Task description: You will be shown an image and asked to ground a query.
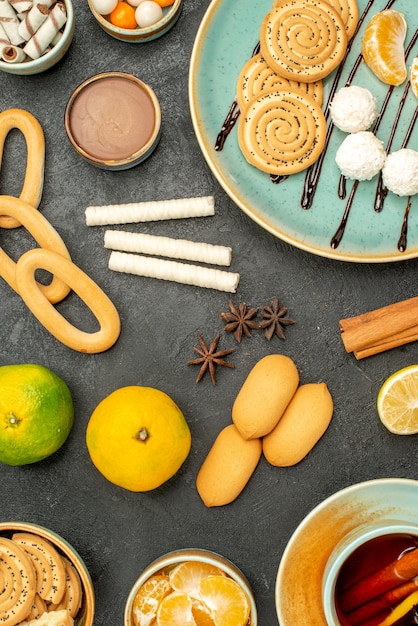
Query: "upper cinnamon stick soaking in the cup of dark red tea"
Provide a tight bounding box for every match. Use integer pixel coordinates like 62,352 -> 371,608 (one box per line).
339,548 -> 418,613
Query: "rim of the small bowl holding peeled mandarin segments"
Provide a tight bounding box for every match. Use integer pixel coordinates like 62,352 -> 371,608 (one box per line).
123,548 -> 258,626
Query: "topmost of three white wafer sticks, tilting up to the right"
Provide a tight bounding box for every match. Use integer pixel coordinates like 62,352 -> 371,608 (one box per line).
85,196 -> 215,226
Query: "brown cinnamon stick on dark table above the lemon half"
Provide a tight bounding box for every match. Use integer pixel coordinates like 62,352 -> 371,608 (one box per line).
340,297 -> 418,359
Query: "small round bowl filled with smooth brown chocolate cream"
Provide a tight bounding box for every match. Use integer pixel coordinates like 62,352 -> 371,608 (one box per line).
64,72 -> 161,170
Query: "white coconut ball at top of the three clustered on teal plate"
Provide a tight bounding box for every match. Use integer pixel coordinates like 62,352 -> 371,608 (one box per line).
329,85 -> 377,133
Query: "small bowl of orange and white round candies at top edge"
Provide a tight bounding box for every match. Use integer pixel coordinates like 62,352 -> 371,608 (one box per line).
88,0 -> 183,43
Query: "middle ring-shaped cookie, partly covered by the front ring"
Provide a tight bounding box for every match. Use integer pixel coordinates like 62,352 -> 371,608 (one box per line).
0,196 -> 70,302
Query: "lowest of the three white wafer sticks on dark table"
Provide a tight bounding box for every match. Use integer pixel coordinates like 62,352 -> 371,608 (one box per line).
109,251 -> 240,293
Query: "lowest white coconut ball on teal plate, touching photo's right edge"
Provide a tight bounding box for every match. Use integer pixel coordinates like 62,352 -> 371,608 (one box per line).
382,148 -> 418,196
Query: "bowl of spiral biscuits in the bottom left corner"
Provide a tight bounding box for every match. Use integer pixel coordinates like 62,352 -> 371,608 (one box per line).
0,522 -> 95,626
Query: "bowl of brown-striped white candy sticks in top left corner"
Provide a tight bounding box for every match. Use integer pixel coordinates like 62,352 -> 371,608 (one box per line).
0,0 -> 75,76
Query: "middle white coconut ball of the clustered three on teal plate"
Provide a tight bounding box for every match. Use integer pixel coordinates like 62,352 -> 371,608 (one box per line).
335,130 -> 386,180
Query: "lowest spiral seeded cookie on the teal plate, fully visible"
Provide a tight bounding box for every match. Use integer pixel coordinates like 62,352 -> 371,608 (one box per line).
238,90 -> 326,175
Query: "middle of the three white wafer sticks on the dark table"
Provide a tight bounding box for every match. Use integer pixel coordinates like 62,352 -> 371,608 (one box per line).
104,230 -> 232,265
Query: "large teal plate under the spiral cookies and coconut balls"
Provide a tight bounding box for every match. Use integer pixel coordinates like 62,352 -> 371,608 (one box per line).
189,0 -> 418,263
